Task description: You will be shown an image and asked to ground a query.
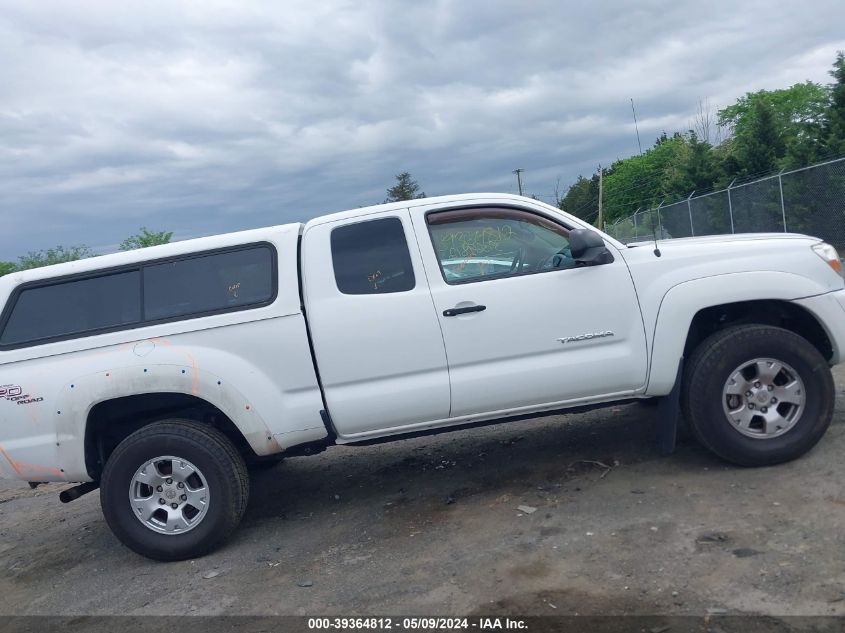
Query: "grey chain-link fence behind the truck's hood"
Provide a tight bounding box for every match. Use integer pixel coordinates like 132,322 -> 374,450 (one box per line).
605,158 -> 845,251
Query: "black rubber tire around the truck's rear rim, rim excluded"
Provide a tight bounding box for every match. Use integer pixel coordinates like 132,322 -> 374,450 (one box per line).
100,420 -> 249,561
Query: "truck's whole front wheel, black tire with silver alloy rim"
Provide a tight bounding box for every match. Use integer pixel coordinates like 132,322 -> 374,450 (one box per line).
681,325 -> 835,466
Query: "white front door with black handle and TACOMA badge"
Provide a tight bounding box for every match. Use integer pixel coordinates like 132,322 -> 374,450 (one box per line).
411,202 -> 647,418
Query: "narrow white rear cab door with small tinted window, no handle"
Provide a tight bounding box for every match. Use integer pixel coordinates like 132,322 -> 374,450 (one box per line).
301,209 -> 449,438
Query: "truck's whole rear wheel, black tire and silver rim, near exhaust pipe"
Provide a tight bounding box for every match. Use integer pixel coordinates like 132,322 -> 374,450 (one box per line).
100,420 -> 249,561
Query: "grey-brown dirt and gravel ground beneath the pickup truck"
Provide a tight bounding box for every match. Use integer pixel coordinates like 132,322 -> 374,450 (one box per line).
0,369 -> 845,616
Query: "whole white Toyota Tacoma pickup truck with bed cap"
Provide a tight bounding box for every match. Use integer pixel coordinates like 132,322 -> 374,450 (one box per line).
0,194 -> 845,560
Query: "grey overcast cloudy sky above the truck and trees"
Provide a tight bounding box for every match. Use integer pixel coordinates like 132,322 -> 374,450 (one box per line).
0,0 -> 845,260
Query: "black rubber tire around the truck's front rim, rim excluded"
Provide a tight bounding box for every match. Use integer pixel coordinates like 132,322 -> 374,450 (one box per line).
681,325 -> 835,466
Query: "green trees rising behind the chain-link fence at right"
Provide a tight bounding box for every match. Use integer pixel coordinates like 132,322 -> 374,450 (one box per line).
558,52 -> 845,222
